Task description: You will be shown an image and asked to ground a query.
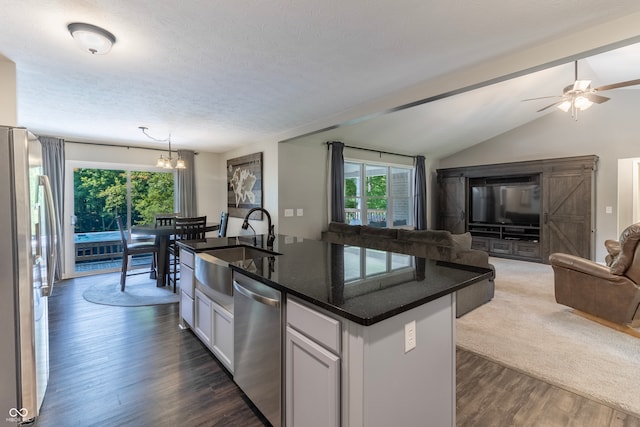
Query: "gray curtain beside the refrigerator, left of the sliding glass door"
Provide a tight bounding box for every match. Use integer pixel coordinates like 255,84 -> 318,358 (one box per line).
38,136 -> 64,281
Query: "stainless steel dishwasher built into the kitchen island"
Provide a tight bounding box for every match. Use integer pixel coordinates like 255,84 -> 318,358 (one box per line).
233,272 -> 282,427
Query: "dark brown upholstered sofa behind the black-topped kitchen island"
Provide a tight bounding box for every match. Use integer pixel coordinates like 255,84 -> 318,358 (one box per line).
322,222 -> 495,317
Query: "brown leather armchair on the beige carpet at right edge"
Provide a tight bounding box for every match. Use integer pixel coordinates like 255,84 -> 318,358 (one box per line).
549,223 -> 640,327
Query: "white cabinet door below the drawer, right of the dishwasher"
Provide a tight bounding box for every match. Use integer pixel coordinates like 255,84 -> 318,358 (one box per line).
285,327 -> 340,427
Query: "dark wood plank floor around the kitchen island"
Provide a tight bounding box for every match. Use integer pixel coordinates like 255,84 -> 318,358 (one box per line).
37,273 -> 640,427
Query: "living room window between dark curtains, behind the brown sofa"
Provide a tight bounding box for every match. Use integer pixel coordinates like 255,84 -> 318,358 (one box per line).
344,162 -> 413,227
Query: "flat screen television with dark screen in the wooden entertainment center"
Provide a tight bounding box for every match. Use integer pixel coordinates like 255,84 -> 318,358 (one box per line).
469,183 -> 540,227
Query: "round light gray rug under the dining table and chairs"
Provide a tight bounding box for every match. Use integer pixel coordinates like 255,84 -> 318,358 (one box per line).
82,273 -> 180,307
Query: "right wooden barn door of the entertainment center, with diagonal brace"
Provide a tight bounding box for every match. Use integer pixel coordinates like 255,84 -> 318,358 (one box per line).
542,167 -> 594,262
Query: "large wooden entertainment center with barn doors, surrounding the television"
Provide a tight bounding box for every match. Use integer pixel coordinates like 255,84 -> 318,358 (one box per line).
436,155 -> 598,263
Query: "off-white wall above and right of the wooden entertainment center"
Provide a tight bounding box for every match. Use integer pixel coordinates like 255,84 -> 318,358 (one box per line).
438,89 -> 640,261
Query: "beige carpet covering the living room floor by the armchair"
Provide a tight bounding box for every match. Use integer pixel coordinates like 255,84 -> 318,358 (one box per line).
456,258 -> 640,416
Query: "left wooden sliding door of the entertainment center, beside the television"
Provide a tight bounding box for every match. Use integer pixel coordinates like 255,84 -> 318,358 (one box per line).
438,176 -> 466,234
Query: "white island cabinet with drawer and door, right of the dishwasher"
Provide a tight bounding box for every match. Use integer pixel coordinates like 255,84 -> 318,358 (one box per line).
285,299 -> 341,427
